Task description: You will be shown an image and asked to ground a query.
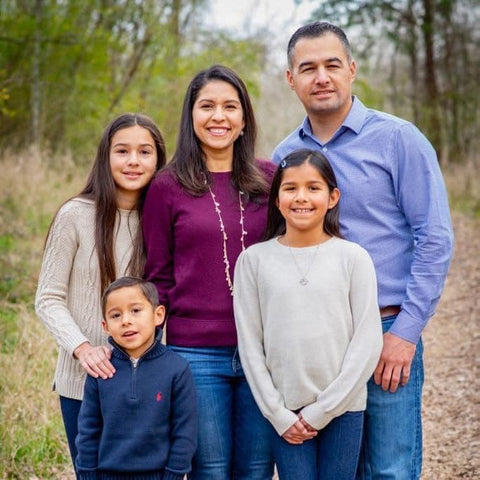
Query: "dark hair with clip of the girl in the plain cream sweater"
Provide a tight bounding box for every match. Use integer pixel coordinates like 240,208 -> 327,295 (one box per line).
263,148 -> 343,240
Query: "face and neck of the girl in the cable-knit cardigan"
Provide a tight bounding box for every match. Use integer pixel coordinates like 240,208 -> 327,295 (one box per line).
110,125 -> 157,210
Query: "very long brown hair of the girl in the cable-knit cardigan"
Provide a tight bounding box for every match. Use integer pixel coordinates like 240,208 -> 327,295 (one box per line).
47,113 -> 166,293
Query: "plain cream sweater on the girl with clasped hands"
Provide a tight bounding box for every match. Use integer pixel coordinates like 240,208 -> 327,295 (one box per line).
234,237 -> 382,435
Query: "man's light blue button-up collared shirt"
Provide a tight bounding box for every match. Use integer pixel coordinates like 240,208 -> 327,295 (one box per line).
273,97 -> 453,343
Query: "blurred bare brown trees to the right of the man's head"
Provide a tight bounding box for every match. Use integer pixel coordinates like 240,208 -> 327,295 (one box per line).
312,0 -> 480,164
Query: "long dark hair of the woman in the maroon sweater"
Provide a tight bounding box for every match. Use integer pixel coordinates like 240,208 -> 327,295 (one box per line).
167,65 -> 268,198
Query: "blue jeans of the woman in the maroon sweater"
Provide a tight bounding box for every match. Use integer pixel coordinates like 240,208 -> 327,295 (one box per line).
169,345 -> 273,480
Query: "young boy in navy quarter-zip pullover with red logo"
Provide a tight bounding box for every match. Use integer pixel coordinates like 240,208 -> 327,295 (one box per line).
76,277 -> 197,480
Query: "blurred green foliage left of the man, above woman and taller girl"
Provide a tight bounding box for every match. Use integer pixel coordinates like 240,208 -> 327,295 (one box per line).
0,0 -> 263,163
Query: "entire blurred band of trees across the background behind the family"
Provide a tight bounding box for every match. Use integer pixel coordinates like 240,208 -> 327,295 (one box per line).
0,0 -> 480,164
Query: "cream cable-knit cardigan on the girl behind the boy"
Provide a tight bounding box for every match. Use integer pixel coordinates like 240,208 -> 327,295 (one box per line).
35,198 -> 138,400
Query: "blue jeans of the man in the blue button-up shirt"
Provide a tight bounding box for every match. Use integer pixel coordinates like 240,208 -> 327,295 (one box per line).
357,317 -> 424,480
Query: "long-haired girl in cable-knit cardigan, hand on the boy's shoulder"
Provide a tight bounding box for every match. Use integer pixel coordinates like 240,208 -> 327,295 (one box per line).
35,113 -> 166,461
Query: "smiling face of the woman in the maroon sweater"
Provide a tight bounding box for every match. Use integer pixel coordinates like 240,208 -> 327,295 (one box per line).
192,80 -> 245,158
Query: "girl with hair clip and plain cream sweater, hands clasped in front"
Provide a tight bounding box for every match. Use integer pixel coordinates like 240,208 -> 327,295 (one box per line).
234,150 -> 382,480
